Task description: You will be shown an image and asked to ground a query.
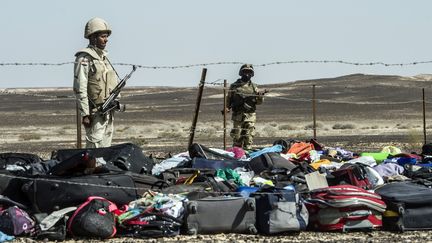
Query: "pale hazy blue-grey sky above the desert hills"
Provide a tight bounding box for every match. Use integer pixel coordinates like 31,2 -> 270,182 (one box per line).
0,0 -> 432,88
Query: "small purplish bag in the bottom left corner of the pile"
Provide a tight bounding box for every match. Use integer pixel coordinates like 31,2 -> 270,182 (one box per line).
0,206 -> 35,235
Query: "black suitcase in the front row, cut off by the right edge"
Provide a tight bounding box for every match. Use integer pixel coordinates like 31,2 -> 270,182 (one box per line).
375,182 -> 432,232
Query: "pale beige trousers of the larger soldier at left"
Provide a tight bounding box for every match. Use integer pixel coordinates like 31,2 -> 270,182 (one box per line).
86,114 -> 114,148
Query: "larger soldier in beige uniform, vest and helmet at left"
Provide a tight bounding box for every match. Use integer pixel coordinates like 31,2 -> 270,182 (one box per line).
74,18 -> 118,148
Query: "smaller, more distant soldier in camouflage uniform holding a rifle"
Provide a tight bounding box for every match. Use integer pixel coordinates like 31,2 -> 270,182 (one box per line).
227,64 -> 264,150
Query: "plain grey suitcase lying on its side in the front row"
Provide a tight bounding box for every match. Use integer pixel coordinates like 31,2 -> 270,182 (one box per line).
185,196 -> 257,235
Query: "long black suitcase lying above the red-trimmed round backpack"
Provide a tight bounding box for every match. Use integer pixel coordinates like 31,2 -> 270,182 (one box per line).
23,173 -> 164,213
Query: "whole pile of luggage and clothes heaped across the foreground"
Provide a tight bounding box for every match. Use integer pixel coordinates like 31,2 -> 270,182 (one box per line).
0,139 -> 432,241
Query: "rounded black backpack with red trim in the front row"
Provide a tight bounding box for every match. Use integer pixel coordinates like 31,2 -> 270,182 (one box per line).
68,197 -> 117,239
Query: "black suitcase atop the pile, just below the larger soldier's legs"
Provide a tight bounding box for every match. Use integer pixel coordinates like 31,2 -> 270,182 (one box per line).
51,143 -> 154,174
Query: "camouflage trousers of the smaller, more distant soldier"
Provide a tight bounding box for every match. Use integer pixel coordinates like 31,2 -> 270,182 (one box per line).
230,113 -> 256,150
